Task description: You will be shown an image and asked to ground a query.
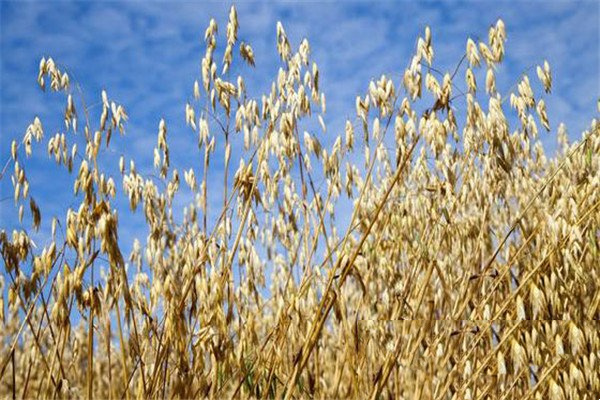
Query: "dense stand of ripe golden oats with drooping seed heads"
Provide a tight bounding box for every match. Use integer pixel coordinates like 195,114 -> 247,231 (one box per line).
0,8 -> 600,400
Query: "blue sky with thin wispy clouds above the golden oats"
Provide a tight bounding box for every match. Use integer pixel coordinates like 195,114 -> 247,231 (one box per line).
0,1 -> 600,260
